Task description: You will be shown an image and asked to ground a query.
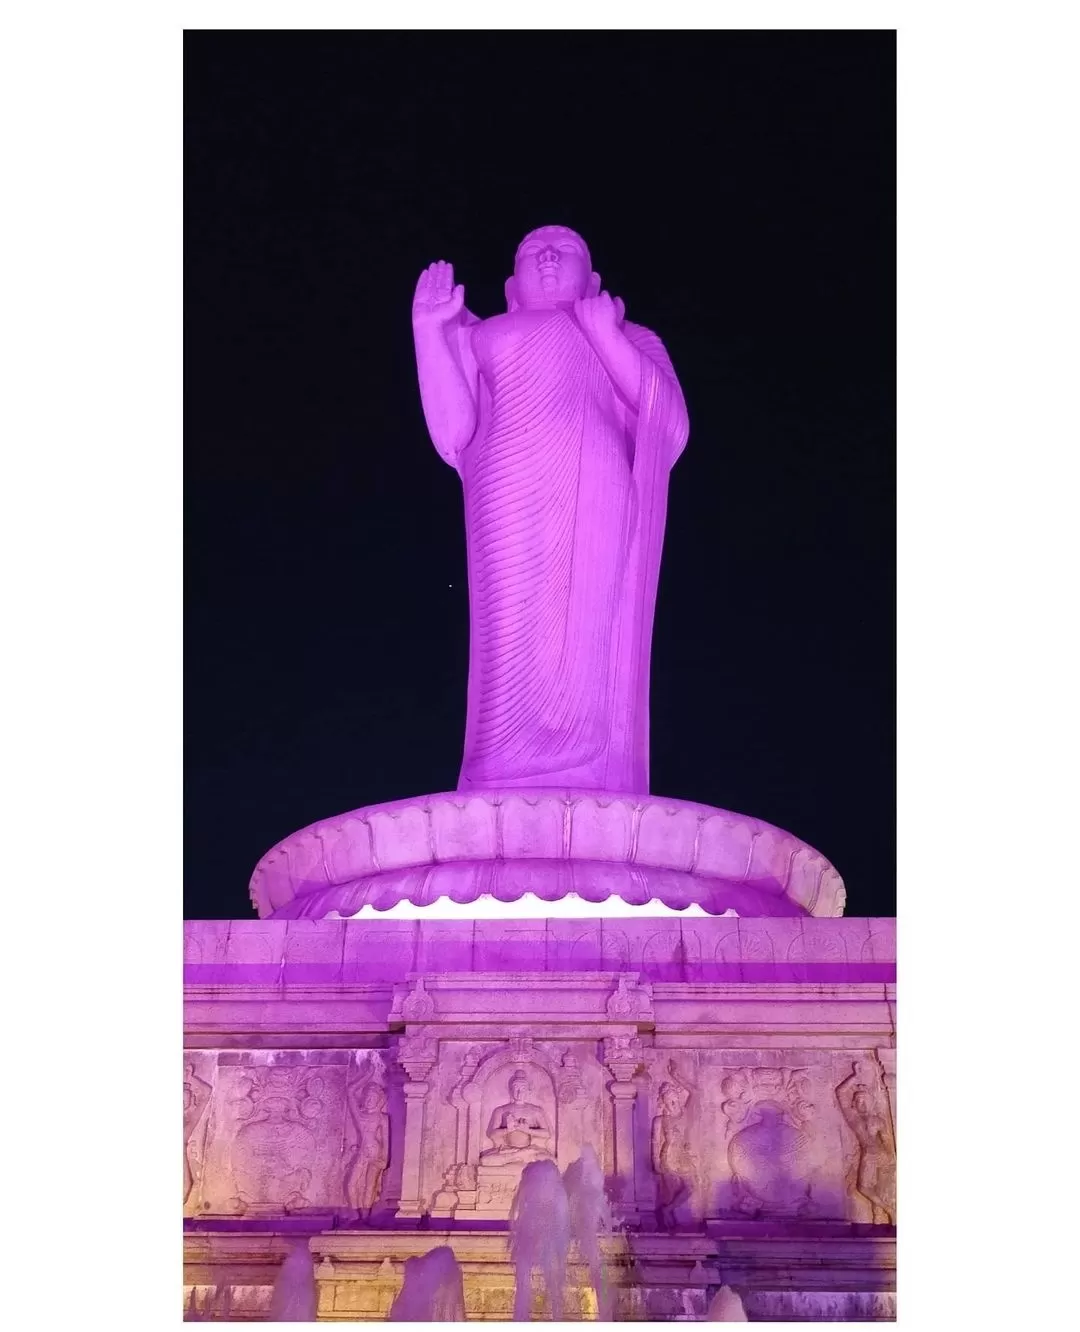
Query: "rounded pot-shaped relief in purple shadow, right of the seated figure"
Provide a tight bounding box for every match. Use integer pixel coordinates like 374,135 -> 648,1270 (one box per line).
720,1068 -> 816,1216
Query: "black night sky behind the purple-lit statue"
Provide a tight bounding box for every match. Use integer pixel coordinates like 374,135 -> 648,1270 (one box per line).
185,31 -> 896,918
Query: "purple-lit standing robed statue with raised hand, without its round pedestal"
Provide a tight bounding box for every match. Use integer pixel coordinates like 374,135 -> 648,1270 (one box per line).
413,226 -> 687,793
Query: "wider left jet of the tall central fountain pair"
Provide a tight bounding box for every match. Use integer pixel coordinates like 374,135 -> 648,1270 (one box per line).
510,1160 -> 570,1323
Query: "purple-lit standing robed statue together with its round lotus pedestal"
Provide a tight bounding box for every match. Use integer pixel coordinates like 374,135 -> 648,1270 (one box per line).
245,226 -> 844,921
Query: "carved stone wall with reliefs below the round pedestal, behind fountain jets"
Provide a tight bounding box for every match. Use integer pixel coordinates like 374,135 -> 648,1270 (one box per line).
184,918 -> 896,1319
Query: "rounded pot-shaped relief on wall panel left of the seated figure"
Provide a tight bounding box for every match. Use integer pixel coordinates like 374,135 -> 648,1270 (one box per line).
230,1067 -> 324,1212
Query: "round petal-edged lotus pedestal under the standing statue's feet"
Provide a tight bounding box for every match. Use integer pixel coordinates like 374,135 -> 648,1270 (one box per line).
250,787 -> 846,920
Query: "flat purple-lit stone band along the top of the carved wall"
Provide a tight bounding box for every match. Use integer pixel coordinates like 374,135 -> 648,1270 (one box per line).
184,916 -> 896,991
